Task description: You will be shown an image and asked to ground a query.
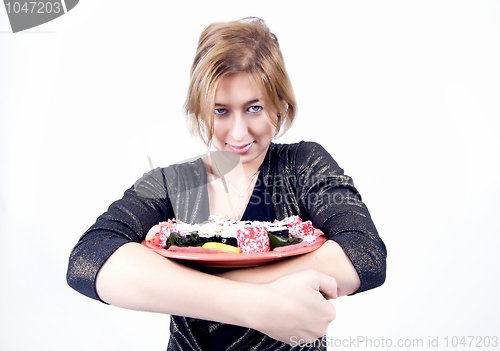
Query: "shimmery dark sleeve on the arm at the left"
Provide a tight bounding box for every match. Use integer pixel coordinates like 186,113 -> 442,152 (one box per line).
66,168 -> 172,300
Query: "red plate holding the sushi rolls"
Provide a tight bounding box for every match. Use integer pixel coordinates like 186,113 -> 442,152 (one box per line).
142,236 -> 326,268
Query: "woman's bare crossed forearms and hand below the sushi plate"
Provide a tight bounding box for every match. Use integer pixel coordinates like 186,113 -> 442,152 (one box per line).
96,240 -> 359,342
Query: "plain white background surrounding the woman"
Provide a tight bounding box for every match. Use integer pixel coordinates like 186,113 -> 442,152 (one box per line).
0,0 -> 500,351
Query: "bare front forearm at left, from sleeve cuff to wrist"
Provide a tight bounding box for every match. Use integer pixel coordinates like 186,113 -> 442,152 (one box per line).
96,243 -> 257,325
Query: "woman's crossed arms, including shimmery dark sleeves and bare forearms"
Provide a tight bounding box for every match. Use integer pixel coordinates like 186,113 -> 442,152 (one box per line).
74,144 -> 386,342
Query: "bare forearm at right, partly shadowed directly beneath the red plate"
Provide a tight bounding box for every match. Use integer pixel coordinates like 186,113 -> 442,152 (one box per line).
220,240 -> 360,296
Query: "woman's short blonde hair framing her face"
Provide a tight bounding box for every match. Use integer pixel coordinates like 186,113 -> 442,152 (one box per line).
185,17 -> 297,145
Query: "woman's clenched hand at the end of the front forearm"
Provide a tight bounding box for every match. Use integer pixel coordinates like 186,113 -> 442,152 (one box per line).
252,270 -> 338,344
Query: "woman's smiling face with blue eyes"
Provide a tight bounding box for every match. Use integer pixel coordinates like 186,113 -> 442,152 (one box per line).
212,73 -> 276,166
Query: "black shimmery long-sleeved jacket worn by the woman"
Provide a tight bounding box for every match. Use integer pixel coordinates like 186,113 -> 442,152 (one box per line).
67,142 -> 387,350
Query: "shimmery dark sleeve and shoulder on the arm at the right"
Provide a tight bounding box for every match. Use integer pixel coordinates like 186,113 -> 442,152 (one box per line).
263,142 -> 387,292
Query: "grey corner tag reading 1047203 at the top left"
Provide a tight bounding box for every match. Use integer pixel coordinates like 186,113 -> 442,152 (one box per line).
4,0 -> 79,33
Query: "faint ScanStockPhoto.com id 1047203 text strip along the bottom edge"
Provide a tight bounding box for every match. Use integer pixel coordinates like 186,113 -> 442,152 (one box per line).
290,335 -> 500,349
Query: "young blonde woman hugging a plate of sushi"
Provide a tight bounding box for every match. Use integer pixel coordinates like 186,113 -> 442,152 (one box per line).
68,18 -> 386,350
